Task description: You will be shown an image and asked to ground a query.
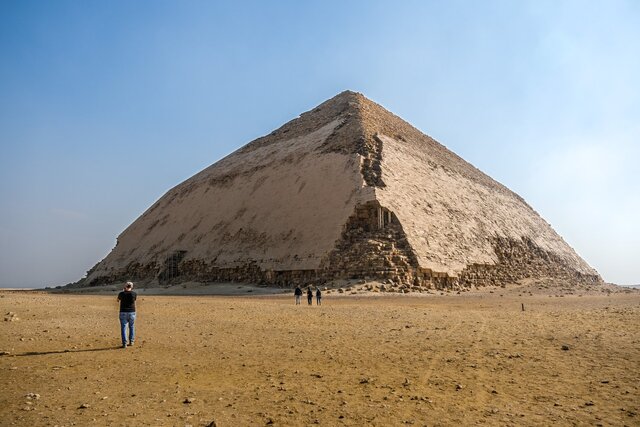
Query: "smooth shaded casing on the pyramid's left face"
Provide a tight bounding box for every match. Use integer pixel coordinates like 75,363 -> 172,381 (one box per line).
92,120 -> 372,284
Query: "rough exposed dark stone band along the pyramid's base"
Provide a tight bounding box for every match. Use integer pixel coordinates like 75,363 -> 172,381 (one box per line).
78,234 -> 603,291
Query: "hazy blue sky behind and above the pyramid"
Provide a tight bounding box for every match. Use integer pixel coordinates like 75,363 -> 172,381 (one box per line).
0,0 -> 640,287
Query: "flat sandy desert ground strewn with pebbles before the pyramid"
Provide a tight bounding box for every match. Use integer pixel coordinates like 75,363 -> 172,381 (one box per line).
0,289 -> 640,426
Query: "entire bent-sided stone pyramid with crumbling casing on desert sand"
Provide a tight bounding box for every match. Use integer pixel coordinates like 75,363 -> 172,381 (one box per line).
81,91 -> 602,287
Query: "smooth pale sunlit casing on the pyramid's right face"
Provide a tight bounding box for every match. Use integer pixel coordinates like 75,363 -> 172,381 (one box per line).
376,135 -> 597,275
